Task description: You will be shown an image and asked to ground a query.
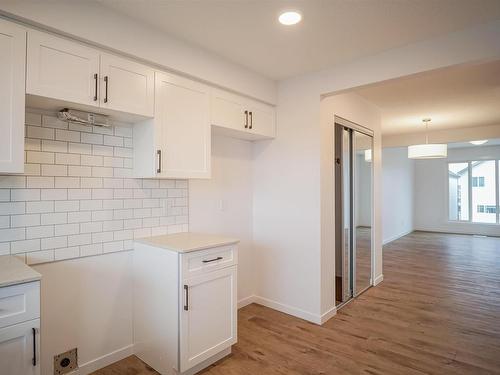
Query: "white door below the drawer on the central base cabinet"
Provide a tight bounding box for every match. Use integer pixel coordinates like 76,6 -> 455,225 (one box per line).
180,267 -> 237,372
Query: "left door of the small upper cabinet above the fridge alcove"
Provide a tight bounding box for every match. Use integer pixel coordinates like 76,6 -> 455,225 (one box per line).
211,89 -> 248,131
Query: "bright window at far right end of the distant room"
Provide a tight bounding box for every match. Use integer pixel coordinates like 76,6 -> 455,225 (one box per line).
448,160 -> 500,224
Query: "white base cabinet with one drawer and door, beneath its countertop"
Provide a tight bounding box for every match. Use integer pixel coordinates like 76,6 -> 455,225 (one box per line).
134,242 -> 237,375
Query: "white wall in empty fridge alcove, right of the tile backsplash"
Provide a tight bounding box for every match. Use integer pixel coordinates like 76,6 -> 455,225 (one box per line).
189,136 -> 255,303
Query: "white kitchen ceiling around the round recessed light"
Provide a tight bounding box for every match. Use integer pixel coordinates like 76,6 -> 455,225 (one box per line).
94,0 -> 500,79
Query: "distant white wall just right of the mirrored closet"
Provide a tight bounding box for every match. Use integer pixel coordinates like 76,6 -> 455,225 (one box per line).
382,147 -> 415,244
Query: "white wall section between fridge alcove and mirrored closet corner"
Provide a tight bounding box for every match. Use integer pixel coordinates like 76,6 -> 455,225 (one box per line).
253,78 -> 320,321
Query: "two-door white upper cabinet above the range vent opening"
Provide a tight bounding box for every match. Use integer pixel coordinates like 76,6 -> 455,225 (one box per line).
26,30 -> 154,117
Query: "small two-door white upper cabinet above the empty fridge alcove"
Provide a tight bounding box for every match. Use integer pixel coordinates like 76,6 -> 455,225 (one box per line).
211,89 -> 276,140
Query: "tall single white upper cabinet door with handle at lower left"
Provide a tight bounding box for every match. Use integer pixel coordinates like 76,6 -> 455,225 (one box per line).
155,73 -> 211,178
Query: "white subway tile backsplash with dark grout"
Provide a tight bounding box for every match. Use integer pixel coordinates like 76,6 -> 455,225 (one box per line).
0,112 -> 188,264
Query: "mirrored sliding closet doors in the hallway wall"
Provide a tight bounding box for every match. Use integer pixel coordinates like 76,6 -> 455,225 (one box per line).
334,117 -> 373,307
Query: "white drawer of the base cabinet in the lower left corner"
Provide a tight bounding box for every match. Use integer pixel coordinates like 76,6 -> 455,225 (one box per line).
0,281 -> 40,328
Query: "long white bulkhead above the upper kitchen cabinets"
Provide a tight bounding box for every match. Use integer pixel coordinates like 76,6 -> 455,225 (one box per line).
0,0 -> 276,104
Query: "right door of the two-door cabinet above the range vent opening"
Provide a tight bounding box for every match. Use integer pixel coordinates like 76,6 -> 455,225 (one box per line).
100,54 -> 154,117
